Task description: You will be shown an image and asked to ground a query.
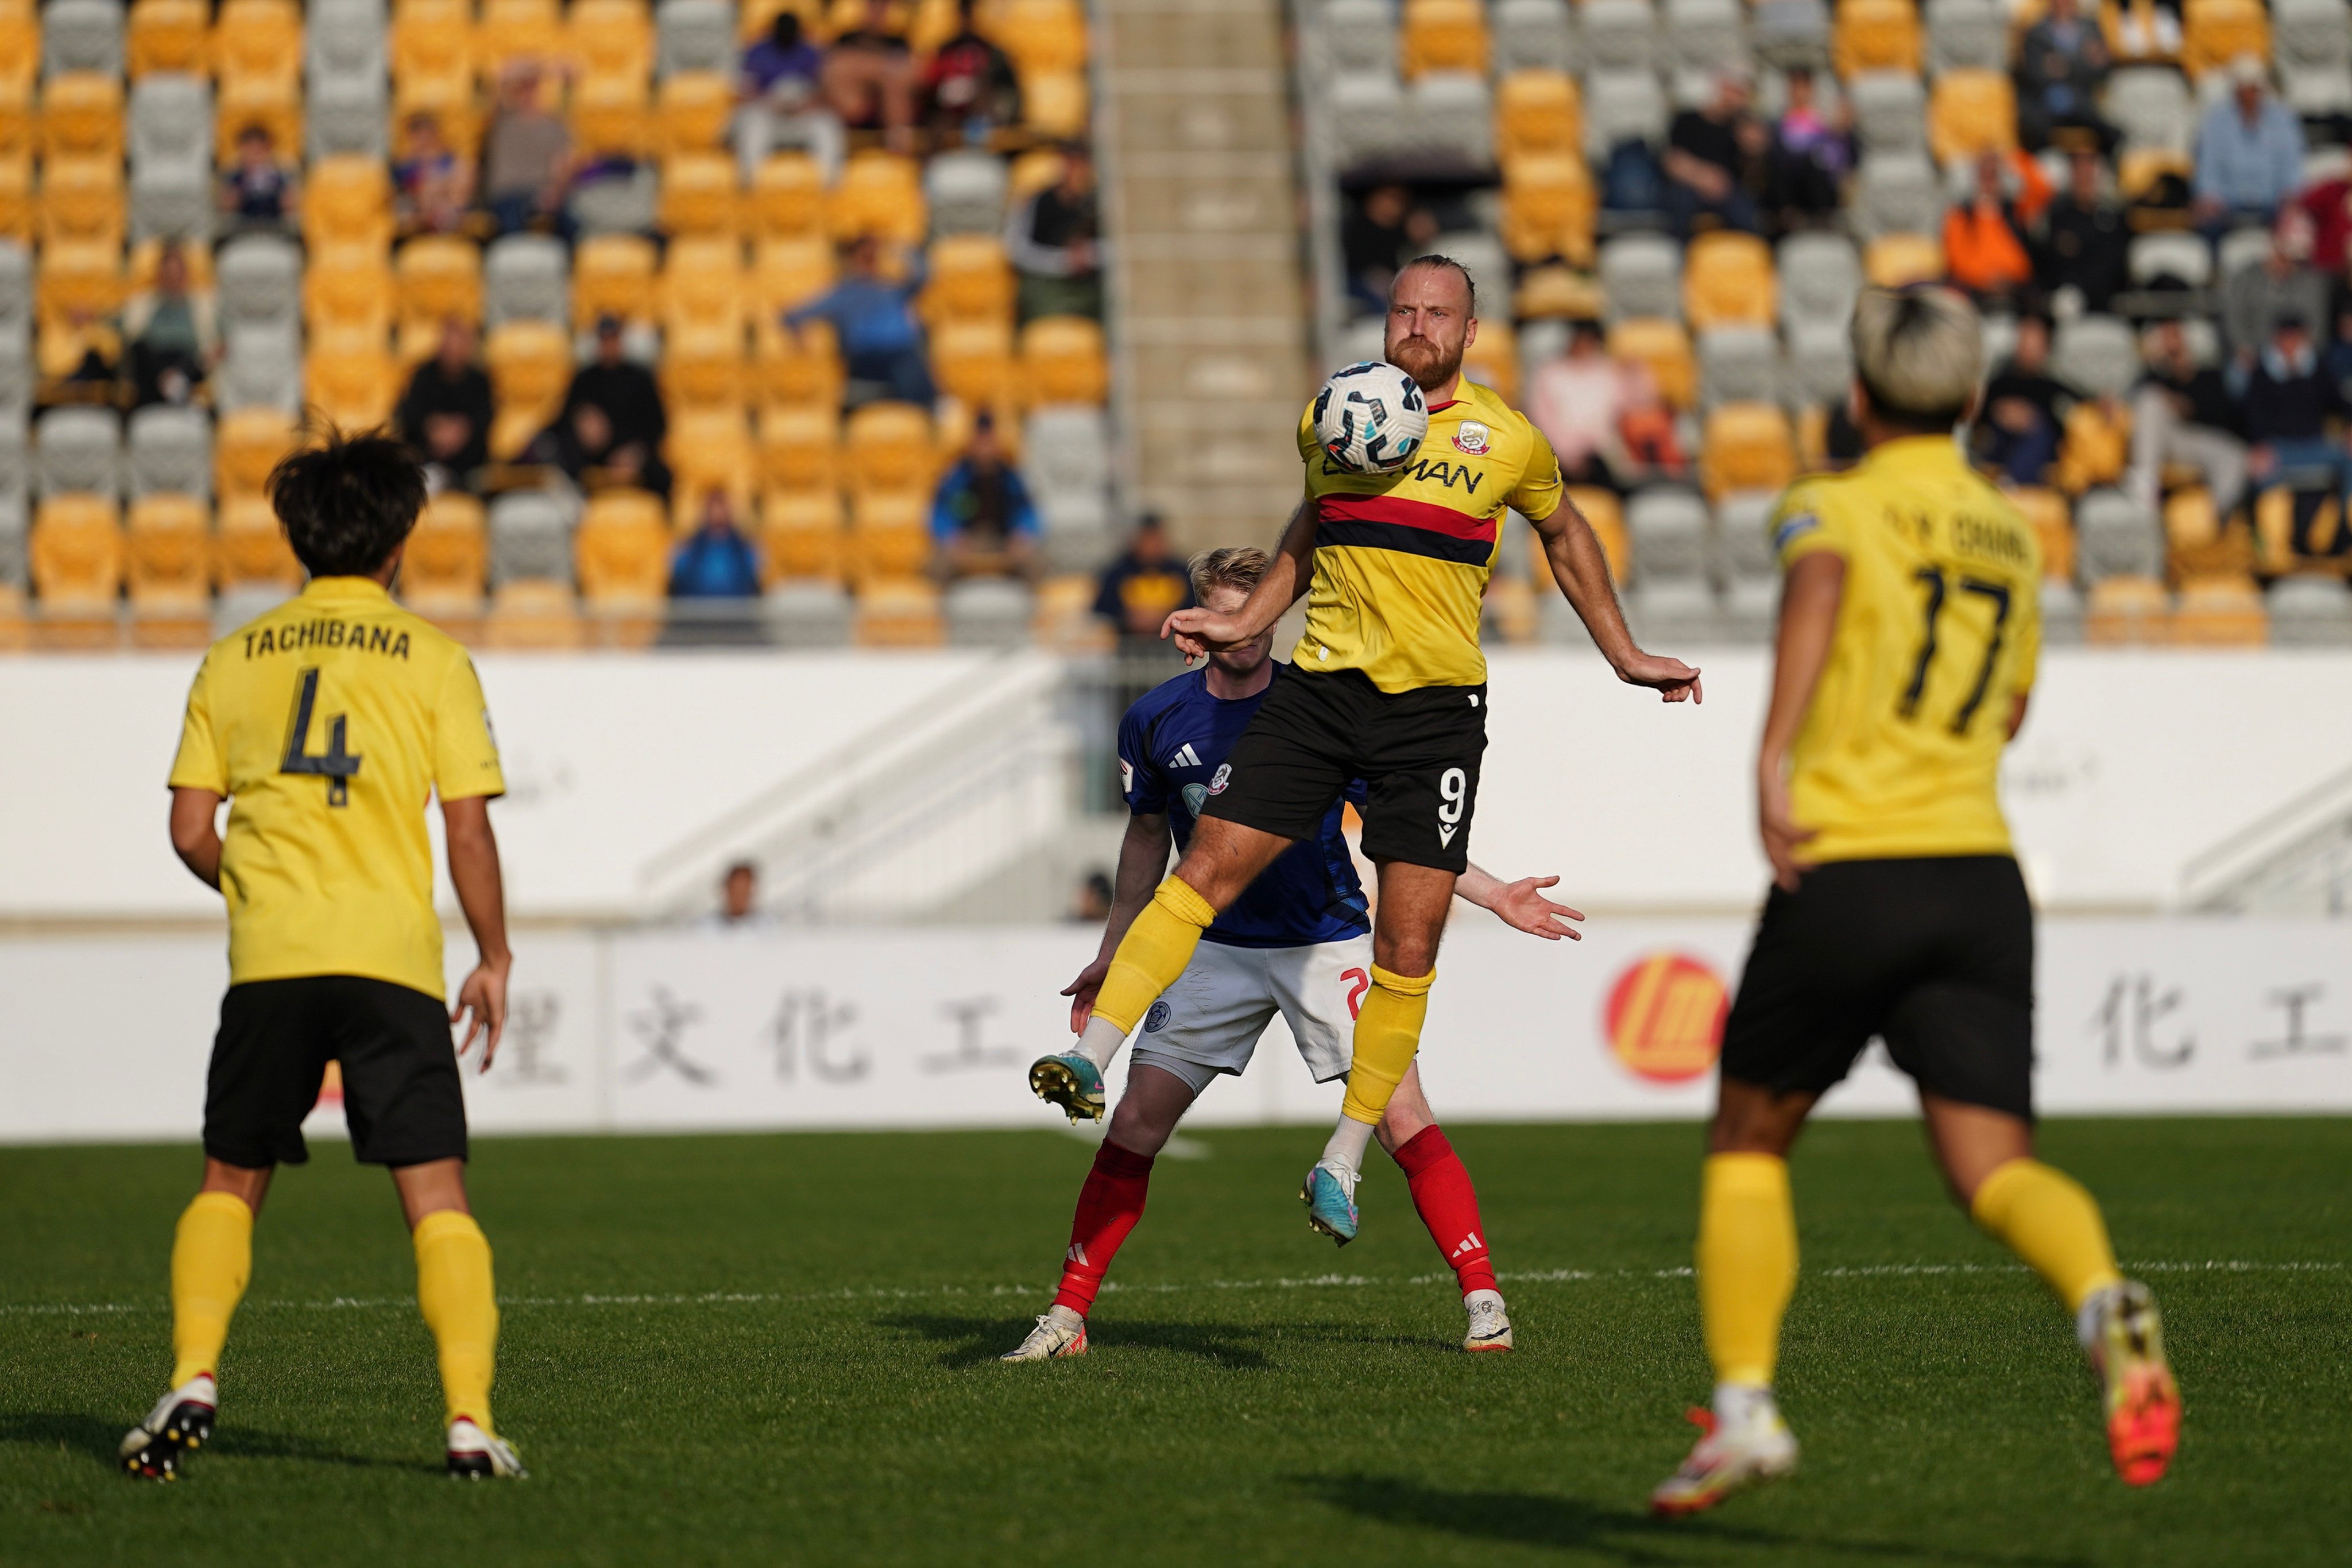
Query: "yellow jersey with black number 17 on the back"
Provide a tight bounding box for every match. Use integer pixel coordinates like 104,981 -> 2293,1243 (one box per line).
1771,435 -> 2041,861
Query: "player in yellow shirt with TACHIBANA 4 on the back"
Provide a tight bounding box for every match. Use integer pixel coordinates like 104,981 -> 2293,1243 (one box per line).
122,438 -> 522,1478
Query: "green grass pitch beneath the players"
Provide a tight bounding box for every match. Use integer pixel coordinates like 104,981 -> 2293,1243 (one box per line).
0,1119 -> 2352,1568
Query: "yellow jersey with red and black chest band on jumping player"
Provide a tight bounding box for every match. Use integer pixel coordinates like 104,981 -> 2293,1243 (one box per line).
1291,378 -> 1562,691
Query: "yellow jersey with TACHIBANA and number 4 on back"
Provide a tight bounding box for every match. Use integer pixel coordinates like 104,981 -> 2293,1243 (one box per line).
172,576 -> 506,997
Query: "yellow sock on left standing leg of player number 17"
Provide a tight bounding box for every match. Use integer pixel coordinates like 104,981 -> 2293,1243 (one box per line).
1698,1154 -> 1797,1387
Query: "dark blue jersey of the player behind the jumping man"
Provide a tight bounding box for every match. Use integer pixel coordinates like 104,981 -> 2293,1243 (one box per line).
1120,663 -> 1371,947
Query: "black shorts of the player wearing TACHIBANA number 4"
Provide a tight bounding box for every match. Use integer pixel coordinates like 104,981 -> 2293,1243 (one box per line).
204,975 -> 466,1168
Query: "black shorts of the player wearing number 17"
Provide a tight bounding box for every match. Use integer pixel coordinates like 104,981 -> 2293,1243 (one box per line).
1724,855 -> 2034,1121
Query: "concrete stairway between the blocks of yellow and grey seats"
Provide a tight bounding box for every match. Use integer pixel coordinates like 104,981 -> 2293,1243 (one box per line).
1094,0 -> 1315,550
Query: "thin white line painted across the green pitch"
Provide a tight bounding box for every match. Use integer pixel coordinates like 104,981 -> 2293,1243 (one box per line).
0,1258 -> 2345,1317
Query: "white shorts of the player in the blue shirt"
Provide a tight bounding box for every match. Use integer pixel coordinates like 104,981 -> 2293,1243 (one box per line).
1136,933 -> 1371,1093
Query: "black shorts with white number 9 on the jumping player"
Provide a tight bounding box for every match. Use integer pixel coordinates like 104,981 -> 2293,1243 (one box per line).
1202,668 -> 1487,874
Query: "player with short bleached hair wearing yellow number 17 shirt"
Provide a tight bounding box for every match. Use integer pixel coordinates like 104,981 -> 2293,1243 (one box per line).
1651,289 -> 2180,1514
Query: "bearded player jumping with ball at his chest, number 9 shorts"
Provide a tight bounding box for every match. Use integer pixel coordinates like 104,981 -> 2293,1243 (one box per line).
1030,256 -> 1700,1246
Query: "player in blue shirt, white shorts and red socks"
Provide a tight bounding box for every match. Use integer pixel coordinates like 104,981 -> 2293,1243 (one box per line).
1004,550 -> 1583,1361
